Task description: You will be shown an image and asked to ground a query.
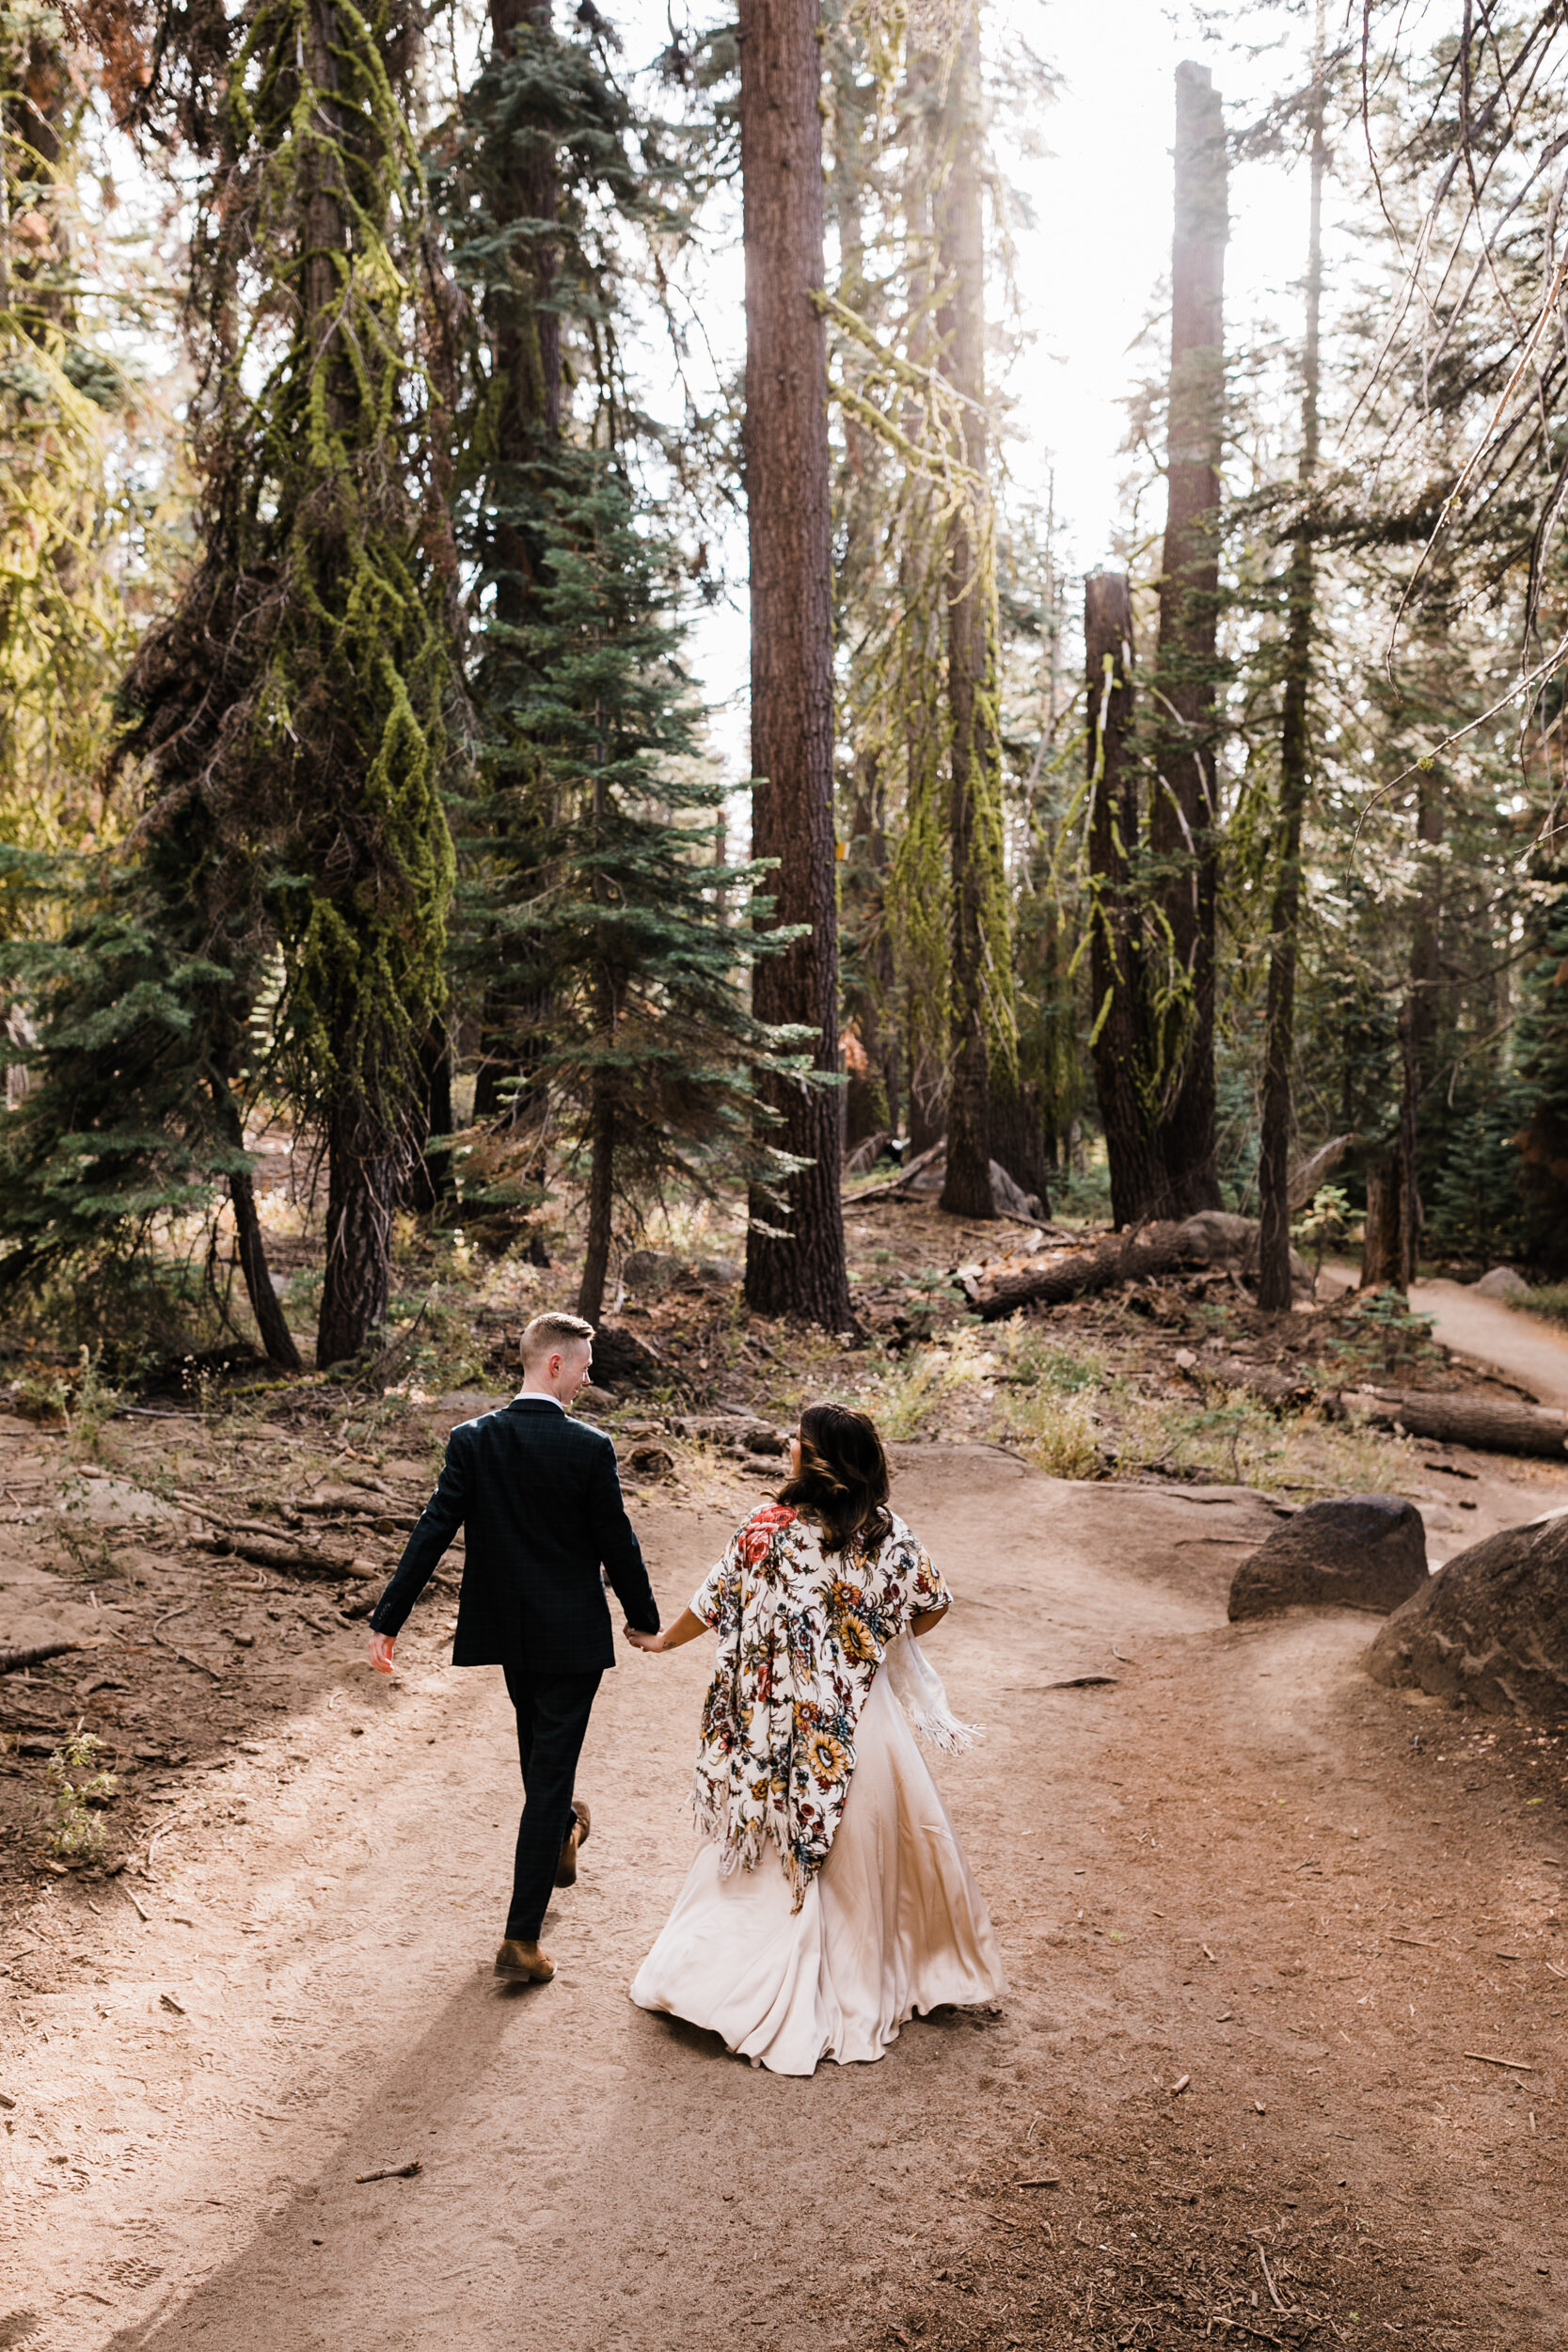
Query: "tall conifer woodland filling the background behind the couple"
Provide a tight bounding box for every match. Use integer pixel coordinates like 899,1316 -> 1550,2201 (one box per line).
0,0 -> 1568,1376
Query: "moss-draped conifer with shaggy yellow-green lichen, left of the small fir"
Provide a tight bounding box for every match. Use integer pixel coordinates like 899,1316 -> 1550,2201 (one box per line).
115,0 -> 461,1362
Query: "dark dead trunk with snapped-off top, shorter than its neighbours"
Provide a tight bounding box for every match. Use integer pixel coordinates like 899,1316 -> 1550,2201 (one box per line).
1084,572 -> 1166,1226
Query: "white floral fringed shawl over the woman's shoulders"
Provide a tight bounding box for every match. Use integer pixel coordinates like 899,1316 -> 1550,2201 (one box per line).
691,1503 -> 950,1910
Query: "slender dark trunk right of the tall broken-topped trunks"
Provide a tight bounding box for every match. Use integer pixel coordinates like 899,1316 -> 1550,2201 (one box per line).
1258,45 -> 1326,1315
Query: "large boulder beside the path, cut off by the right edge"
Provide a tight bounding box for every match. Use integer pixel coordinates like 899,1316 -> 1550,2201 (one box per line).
1366,1515 -> 1568,1722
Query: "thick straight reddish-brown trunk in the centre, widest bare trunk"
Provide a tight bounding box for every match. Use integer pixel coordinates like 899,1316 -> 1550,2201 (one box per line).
740,0 -> 853,1331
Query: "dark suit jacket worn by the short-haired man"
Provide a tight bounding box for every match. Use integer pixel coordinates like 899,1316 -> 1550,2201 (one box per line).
372,1400 -> 658,1675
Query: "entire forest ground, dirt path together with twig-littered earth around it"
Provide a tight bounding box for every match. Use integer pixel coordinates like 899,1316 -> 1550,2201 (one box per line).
0,1202 -> 1568,2352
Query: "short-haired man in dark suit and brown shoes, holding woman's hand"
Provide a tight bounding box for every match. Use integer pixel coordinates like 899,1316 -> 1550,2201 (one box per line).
369,1315 -> 658,1983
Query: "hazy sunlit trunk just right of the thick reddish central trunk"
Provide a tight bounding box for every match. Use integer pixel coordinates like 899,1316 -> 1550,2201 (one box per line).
936,8 -> 1011,1216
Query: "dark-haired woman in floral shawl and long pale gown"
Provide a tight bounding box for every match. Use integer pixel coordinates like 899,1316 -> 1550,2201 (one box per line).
627,1405 -> 1006,2074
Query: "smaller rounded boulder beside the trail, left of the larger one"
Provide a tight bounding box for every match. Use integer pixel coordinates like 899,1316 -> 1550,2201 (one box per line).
1229,1494 -> 1427,1626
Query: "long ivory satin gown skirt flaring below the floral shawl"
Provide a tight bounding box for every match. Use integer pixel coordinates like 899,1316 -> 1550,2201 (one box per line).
632,1668 -> 1006,2074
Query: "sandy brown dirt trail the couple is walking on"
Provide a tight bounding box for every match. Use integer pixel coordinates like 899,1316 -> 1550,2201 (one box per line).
0,1447 -> 1568,2352
